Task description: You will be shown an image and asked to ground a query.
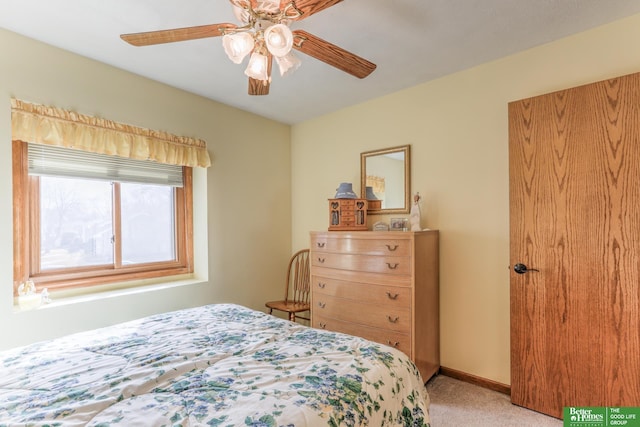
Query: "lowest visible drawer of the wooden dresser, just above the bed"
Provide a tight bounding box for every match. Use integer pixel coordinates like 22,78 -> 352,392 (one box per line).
311,315 -> 411,356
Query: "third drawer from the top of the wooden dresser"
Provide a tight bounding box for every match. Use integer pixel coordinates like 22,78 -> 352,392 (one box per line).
311,276 -> 411,308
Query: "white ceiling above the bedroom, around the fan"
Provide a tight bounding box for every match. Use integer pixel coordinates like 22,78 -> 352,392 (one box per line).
0,0 -> 640,124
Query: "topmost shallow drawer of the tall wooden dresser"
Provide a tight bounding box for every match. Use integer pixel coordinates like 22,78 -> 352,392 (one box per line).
311,236 -> 411,256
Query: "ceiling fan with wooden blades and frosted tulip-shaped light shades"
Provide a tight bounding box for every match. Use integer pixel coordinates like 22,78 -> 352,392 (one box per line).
120,0 -> 376,95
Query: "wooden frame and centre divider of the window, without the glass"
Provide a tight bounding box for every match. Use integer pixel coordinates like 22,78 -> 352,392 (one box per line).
12,140 -> 194,295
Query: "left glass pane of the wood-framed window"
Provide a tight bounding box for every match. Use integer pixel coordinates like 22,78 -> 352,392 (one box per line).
40,176 -> 113,271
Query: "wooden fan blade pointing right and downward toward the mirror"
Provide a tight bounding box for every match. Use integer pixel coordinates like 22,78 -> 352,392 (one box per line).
293,30 -> 376,79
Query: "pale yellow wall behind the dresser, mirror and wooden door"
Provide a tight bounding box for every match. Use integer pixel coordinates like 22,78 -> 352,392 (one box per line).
292,15 -> 640,384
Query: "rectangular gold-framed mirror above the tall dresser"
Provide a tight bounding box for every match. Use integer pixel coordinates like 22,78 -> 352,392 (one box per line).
360,145 -> 411,215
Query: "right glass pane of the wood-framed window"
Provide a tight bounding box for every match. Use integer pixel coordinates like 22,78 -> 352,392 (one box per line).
120,183 -> 176,265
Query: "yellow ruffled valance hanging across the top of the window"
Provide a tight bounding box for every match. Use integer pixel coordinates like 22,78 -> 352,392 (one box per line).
11,98 -> 211,168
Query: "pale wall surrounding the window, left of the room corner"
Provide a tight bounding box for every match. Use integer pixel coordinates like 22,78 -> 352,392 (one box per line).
0,30 -> 291,349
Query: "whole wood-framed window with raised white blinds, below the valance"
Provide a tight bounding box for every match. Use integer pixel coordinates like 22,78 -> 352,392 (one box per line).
13,141 -> 193,292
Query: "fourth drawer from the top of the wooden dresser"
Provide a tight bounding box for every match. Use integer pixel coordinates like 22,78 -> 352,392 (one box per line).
311,293 -> 411,333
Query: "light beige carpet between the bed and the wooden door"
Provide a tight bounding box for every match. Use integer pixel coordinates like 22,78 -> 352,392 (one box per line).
427,375 -> 562,427
